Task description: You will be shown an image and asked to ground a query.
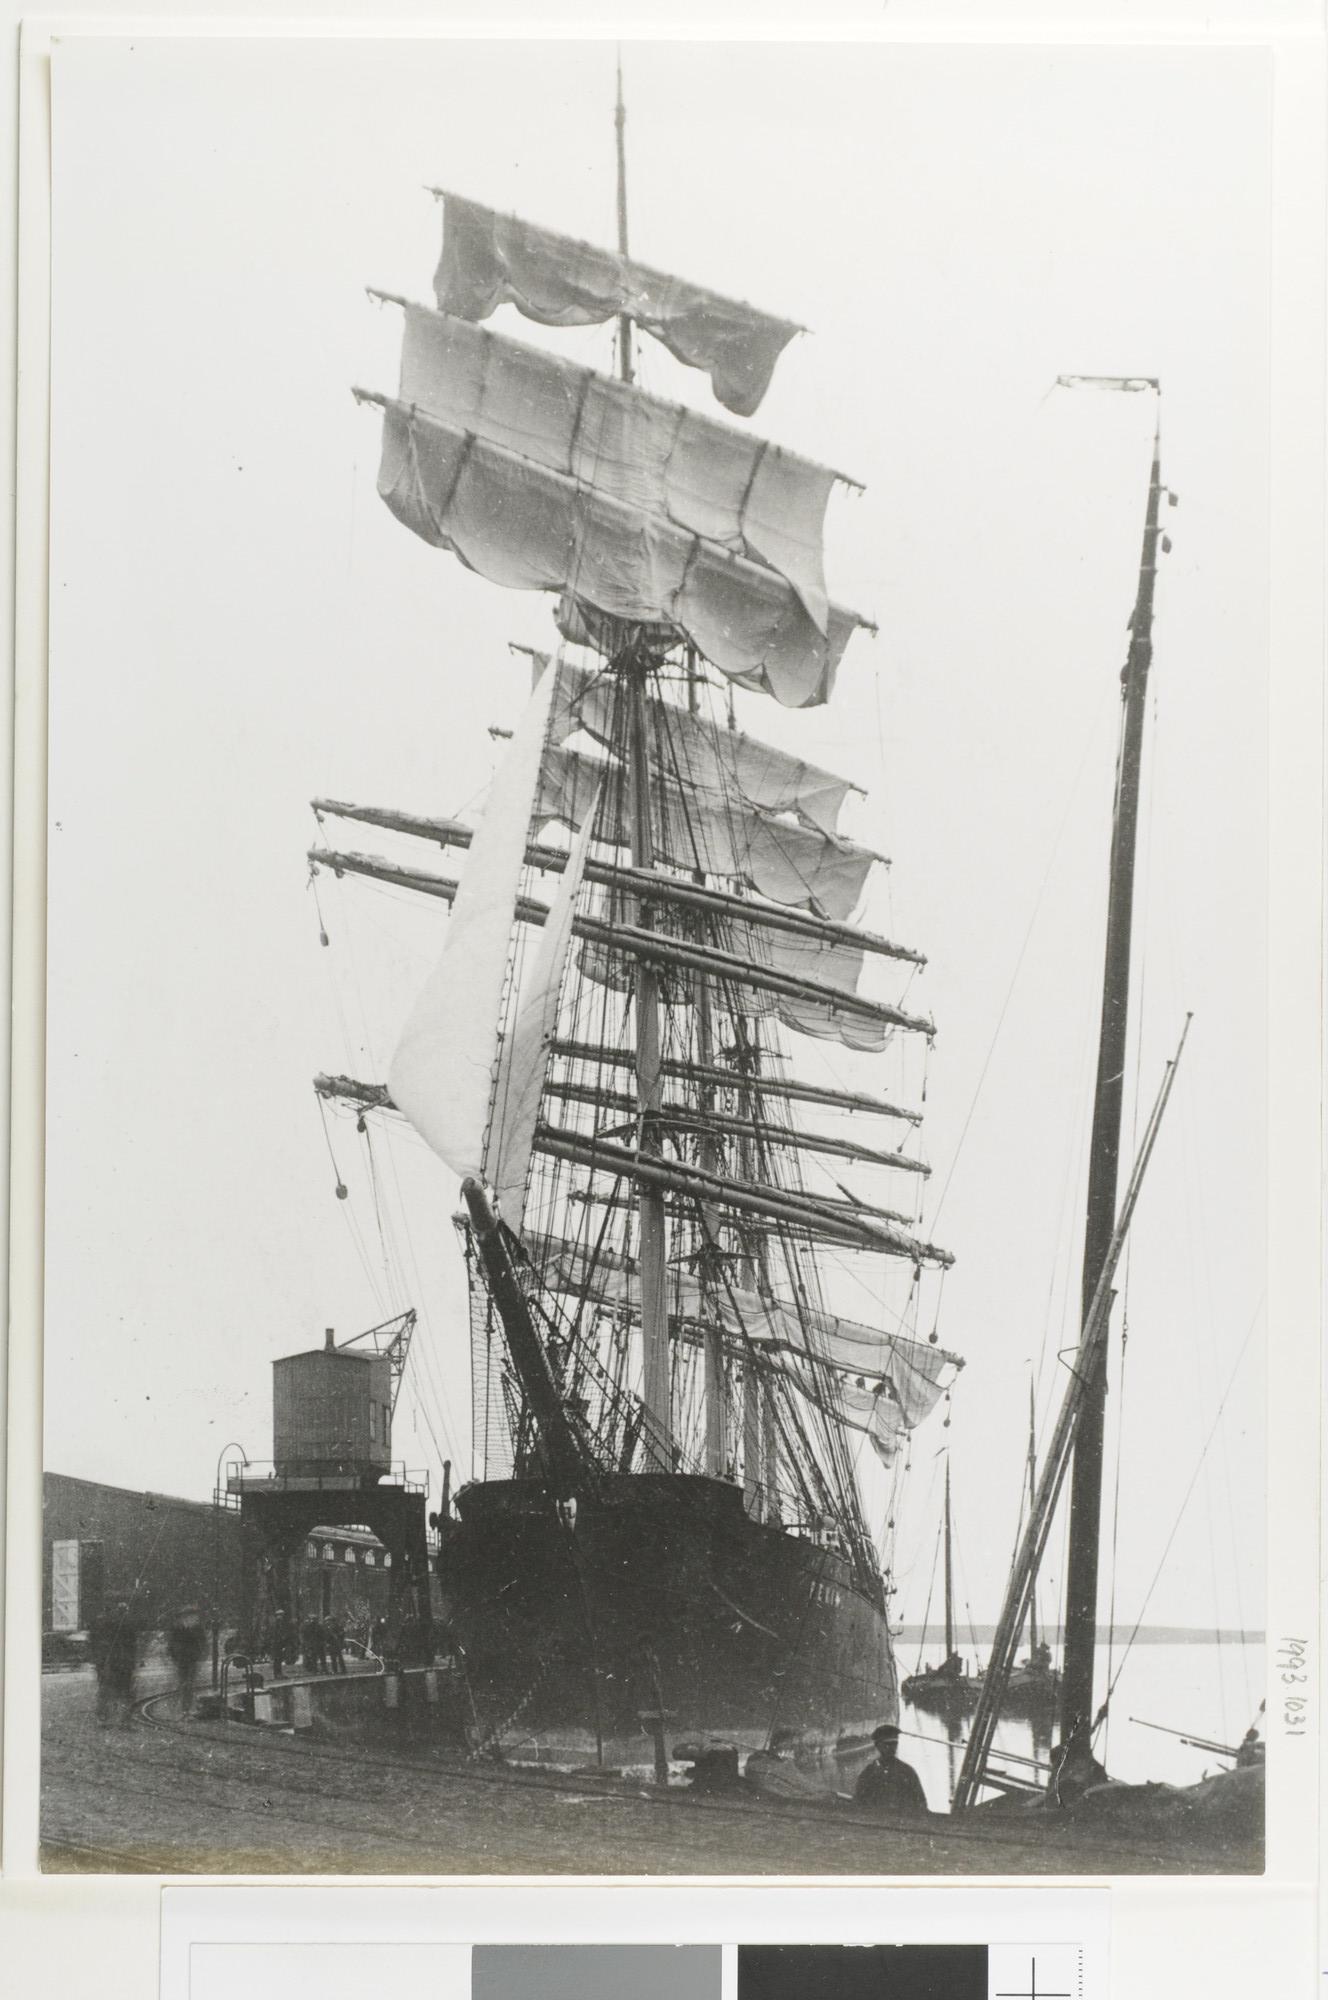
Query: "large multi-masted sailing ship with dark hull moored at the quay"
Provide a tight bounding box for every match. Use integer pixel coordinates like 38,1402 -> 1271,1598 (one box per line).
310,100 -> 962,1788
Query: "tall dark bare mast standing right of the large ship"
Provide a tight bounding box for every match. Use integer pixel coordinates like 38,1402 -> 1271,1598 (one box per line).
1060,398 -> 1162,1750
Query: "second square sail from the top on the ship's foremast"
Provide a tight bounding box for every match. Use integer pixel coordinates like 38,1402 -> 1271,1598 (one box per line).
400,312 -> 838,632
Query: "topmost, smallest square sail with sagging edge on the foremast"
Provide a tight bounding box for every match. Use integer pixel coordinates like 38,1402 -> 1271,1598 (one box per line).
434,190 -> 798,416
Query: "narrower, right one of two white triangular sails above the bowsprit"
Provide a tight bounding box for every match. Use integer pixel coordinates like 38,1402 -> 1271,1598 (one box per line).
486,796 -> 594,1236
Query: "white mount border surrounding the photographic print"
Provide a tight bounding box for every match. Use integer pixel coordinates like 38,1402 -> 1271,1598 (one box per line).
0,0 -> 1326,2000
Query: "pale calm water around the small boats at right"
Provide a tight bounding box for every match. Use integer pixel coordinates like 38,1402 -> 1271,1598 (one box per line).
898,1642 -> 1264,1812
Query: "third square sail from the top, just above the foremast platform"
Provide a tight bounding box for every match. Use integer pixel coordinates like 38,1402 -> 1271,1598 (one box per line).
356,390 -> 866,708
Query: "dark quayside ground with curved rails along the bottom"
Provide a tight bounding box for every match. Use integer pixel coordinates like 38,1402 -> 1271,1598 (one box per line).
42,1670 -> 1262,1876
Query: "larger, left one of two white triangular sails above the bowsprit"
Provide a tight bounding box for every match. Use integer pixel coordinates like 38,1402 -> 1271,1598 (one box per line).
388,674 -> 554,1176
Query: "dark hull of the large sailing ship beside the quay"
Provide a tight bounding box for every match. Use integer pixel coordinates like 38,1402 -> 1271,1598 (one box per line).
442,1474 -> 898,1784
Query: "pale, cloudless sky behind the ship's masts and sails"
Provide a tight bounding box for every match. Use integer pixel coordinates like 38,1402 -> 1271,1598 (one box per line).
44,40 -> 1270,1628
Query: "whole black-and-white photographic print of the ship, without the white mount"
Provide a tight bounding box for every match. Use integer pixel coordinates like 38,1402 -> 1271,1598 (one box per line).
31,34 -> 1280,1872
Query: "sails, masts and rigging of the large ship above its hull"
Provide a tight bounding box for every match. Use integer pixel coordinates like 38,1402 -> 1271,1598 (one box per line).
332,168 -> 960,1560
